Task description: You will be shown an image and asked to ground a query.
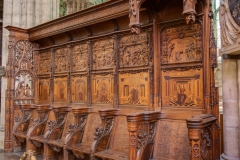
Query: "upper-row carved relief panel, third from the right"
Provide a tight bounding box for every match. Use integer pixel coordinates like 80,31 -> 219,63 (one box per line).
92,39 -> 114,70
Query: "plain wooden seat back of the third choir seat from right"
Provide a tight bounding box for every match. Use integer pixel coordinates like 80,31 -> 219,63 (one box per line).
82,113 -> 102,146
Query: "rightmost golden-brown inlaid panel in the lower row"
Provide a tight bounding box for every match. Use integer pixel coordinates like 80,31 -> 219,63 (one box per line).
162,69 -> 203,107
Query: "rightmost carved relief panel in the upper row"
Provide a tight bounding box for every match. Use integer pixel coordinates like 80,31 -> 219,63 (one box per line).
161,22 -> 202,64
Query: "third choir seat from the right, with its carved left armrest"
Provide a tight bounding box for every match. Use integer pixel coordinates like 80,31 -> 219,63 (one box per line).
64,108 -> 101,159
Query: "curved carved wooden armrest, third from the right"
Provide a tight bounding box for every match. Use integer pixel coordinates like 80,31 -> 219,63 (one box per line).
90,109 -> 119,158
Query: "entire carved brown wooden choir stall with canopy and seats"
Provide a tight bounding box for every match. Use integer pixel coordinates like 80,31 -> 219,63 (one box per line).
5,0 -> 220,160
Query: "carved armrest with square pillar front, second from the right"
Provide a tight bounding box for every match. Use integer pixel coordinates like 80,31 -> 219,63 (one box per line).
127,111 -> 161,160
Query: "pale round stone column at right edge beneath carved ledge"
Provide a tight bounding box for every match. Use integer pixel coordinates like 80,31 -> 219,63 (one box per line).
221,59 -> 240,160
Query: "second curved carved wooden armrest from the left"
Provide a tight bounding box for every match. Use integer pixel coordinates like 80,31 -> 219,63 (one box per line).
27,105 -> 52,137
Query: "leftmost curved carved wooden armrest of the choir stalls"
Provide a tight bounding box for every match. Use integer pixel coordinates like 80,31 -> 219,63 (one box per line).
13,104 -> 35,134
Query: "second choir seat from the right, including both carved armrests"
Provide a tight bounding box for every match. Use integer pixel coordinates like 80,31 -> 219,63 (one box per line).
91,110 -> 161,160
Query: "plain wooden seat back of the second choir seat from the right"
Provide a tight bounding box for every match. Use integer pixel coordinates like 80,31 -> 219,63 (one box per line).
110,116 -> 129,153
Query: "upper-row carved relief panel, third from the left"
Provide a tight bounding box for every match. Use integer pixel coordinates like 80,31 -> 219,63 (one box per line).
72,43 -> 88,71
